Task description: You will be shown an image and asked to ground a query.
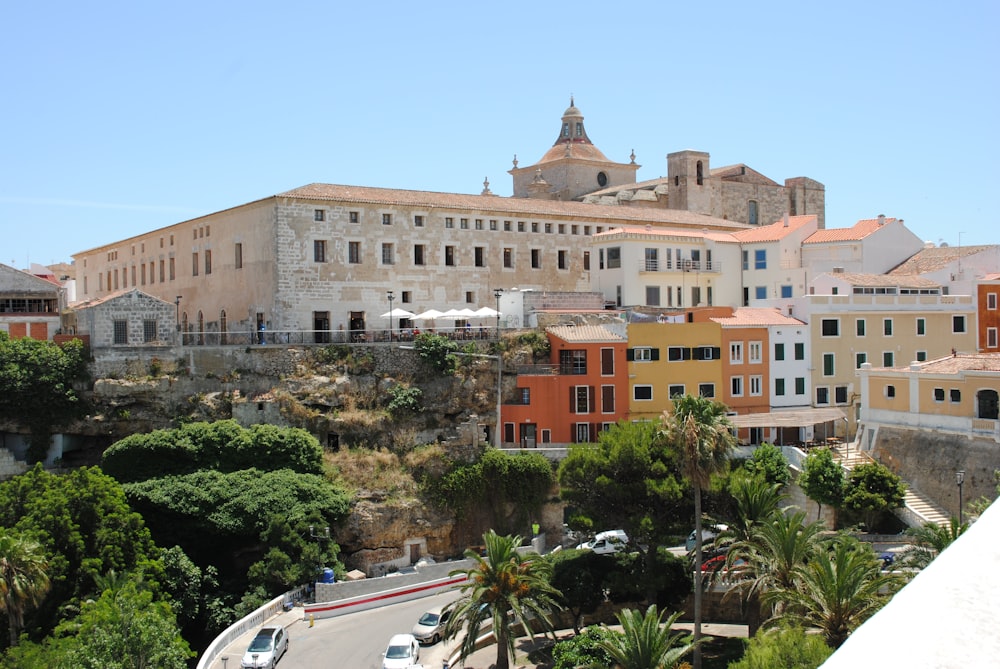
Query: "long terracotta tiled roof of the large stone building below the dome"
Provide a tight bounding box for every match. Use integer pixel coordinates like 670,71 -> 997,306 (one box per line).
274,183 -> 749,230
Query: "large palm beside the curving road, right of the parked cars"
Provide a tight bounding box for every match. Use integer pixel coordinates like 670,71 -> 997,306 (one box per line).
444,530 -> 561,669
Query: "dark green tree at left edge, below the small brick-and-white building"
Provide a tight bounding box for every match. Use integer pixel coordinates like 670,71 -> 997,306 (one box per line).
0,332 -> 87,462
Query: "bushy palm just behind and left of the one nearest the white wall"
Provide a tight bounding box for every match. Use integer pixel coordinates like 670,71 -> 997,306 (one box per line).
725,511 -> 823,635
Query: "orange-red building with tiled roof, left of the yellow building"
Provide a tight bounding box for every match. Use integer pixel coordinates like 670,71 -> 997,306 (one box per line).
500,323 -> 629,448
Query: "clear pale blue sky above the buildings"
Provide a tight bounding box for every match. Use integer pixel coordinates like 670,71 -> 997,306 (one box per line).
0,0 -> 1000,268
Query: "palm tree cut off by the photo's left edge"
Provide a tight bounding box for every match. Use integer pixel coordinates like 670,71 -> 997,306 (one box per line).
0,528 -> 49,646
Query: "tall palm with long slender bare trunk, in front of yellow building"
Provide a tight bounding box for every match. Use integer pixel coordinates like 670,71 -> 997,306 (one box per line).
663,395 -> 736,669
